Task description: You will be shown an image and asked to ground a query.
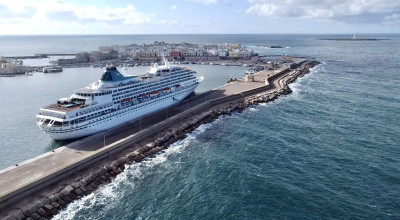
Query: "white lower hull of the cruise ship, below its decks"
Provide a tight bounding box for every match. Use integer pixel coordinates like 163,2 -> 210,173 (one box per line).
38,85 -> 197,140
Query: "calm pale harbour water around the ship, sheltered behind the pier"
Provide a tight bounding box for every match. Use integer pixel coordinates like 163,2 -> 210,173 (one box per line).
0,65 -> 246,169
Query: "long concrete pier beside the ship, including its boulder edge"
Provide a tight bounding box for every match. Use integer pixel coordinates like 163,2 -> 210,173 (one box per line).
0,60 -> 319,219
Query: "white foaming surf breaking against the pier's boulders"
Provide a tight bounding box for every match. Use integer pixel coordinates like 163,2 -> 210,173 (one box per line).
53,123 -> 218,220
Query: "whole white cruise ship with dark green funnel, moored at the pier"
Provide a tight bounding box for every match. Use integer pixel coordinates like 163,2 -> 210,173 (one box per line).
36,60 -> 200,140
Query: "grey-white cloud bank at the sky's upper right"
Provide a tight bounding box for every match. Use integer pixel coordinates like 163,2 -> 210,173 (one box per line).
246,0 -> 400,23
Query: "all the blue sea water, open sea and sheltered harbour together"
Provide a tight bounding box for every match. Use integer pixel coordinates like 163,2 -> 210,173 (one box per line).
0,34 -> 400,220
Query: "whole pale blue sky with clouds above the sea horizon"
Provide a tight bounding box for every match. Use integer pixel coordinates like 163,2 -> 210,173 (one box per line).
0,0 -> 400,35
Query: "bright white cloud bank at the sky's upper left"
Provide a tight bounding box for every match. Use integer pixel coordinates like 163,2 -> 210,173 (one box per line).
0,0 -> 160,24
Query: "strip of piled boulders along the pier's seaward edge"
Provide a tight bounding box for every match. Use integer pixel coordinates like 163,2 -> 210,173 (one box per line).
5,61 -> 319,220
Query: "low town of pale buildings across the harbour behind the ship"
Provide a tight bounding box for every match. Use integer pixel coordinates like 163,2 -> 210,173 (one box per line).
0,41 -> 292,76
